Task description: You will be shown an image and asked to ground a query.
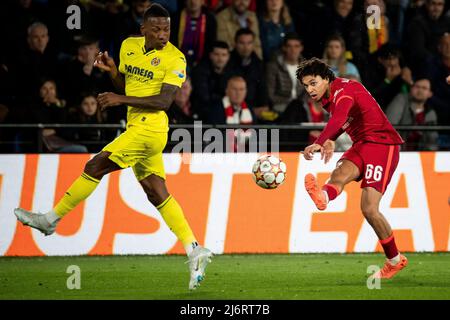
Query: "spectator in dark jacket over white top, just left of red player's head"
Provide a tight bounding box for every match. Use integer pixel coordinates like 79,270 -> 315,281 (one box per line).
266,33 -> 304,114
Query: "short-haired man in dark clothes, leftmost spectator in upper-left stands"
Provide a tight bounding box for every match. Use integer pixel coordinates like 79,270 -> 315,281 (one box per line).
11,22 -> 57,103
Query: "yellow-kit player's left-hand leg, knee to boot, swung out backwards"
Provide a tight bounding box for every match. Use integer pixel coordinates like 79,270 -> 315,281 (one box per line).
14,152 -> 121,235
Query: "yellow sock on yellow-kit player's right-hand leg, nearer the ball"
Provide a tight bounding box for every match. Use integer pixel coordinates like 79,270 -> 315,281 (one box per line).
156,196 -> 198,250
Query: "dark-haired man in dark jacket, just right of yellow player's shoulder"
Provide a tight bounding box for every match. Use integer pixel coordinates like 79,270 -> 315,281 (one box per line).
192,41 -> 231,119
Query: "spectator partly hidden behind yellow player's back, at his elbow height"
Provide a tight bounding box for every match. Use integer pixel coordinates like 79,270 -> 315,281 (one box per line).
167,77 -> 193,124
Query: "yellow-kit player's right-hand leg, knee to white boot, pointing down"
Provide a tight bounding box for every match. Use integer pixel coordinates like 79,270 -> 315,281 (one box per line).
140,174 -> 212,290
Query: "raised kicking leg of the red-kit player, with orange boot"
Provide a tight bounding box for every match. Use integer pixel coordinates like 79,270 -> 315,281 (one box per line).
305,159 -> 360,210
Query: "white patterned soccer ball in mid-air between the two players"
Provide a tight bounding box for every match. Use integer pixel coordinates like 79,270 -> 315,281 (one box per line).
252,155 -> 286,189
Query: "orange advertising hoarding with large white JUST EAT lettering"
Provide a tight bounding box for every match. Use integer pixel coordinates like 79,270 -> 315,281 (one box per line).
0,152 -> 450,256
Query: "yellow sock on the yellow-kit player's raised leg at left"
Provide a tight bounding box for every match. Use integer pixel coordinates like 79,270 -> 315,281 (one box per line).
53,172 -> 100,218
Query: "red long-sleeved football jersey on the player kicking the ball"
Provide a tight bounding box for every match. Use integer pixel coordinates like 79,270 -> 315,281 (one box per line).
315,78 -> 404,145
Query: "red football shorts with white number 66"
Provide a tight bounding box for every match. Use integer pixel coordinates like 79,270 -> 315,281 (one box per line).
340,142 -> 400,194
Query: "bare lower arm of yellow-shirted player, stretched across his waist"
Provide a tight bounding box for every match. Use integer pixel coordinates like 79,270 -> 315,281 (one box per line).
97,83 -> 178,111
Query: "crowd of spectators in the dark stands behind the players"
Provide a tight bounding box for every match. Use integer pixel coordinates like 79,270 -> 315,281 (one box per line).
0,0 -> 450,152
